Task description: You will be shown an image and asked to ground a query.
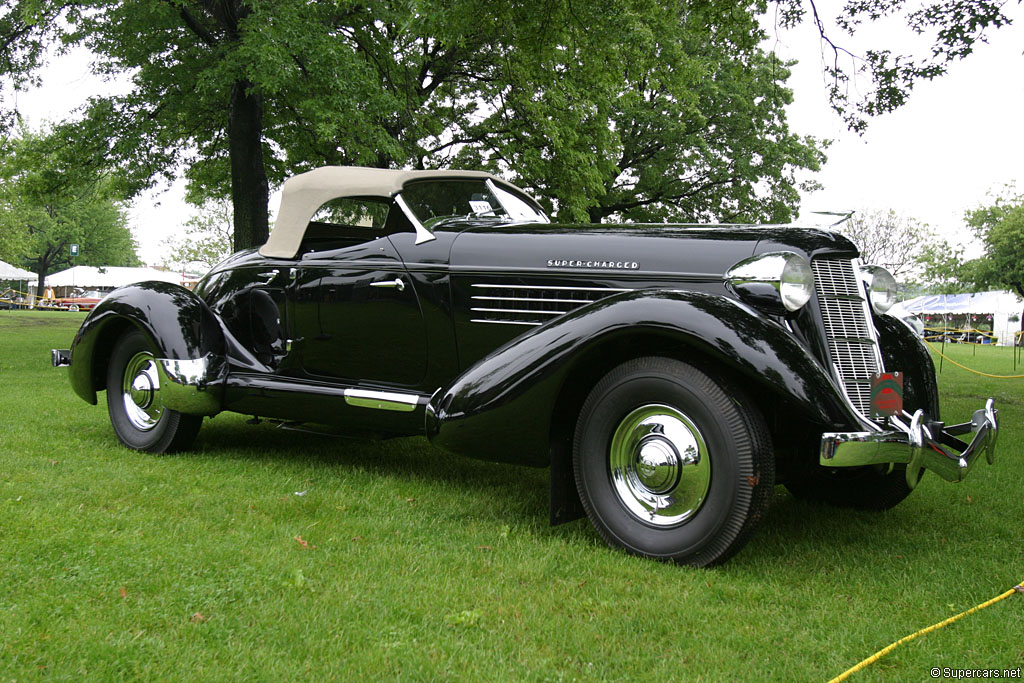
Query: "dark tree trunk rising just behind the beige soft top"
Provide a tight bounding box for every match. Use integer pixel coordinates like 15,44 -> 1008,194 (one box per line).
227,81 -> 269,251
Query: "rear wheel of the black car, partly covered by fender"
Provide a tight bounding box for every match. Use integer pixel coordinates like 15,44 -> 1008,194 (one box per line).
106,330 -> 203,453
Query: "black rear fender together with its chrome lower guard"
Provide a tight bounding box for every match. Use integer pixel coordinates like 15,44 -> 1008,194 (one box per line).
69,282 -> 225,414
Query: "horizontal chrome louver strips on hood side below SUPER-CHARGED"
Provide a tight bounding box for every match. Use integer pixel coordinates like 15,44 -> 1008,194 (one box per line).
470,285 -> 630,326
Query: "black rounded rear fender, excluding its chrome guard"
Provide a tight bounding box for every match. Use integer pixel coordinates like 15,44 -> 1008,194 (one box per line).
69,282 -> 225,404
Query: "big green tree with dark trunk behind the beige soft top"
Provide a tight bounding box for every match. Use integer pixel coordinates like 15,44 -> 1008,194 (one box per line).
0,0 -> 540,248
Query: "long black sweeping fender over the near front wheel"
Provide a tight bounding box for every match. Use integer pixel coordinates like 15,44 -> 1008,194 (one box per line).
426,290 -> 861,465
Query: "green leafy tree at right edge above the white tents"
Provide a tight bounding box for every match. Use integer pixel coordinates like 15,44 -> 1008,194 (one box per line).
966,187 -> 1024,297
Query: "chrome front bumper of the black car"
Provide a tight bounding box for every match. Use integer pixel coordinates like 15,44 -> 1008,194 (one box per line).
819,398 -> 999,488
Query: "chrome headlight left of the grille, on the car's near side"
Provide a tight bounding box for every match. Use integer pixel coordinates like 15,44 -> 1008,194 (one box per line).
725,251 -> 814,314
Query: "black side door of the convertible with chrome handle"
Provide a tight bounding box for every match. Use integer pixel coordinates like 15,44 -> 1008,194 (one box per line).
295,231 -> 428,387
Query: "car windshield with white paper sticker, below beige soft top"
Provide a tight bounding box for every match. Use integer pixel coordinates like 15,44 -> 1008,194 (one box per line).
401,179 -> 548,228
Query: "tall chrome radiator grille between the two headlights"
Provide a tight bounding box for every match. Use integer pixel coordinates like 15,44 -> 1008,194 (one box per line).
811,258 -> 882,417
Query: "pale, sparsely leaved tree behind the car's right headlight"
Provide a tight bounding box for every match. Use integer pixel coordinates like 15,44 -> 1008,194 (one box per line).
836,209 -> 936,280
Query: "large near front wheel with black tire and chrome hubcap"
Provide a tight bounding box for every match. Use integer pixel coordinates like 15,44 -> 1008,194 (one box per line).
572,357 -> 775,566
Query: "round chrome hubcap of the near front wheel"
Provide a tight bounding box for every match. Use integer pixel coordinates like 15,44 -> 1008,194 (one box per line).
608,404 -> 711,526
